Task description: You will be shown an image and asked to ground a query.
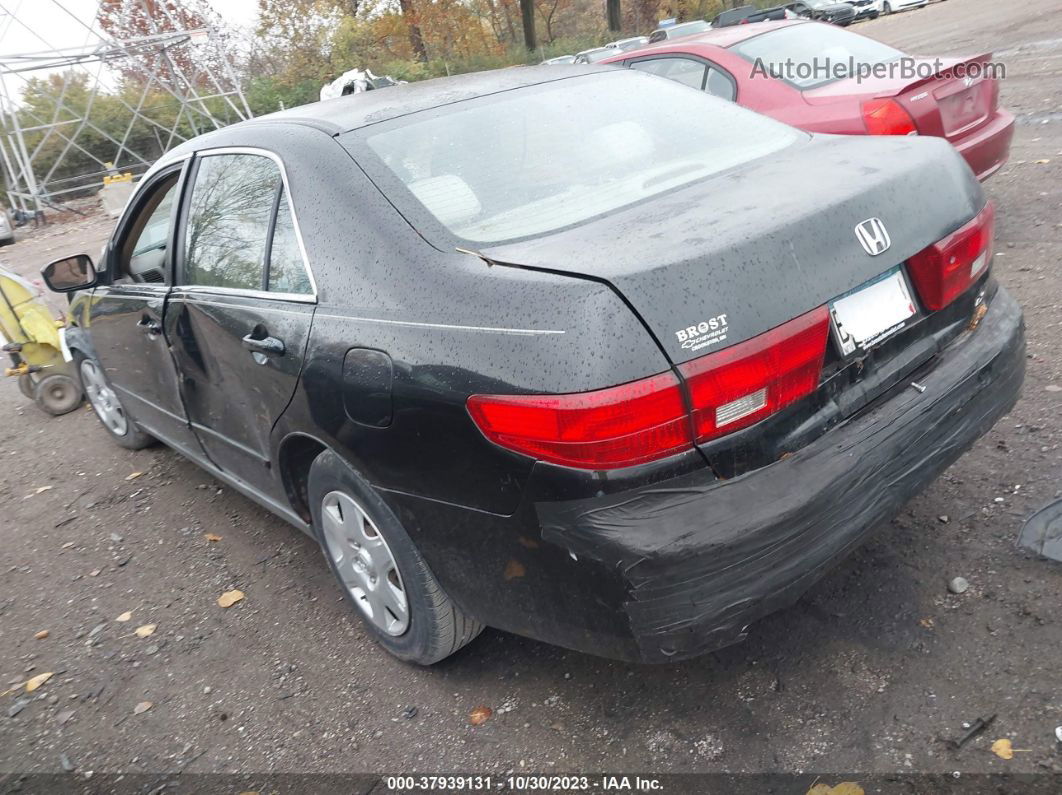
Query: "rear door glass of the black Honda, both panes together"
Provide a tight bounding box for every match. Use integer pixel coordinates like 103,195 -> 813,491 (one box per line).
182,154 -> 313,295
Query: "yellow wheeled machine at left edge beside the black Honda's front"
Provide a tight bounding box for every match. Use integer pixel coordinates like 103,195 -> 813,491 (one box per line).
0,267 -> 83,415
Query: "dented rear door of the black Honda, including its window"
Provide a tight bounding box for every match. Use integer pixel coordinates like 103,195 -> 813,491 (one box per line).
166,149 -> 316,495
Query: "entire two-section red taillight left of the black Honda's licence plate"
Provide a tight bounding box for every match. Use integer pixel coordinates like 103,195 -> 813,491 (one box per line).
468,307 -> 829,469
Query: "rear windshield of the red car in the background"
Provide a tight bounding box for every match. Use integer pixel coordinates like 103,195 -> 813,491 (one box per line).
731,23 -> 904,91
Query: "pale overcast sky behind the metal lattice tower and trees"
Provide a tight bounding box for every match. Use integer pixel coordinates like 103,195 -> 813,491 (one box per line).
0,0 -> 258,99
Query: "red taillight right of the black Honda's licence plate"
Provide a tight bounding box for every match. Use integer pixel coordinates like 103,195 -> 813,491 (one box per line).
907,202 -> 995,310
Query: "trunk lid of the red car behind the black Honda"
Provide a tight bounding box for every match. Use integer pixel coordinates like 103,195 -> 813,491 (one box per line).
804,53 -> 999,142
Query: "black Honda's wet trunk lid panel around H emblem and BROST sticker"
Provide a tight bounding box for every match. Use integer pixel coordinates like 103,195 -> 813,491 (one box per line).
481,136 -> 984,364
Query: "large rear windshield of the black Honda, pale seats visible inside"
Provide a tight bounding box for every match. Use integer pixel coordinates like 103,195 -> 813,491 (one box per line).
348,70 -> 805,243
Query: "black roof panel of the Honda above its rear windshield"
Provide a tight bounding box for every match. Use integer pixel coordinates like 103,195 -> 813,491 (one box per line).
252,64 -> 615,134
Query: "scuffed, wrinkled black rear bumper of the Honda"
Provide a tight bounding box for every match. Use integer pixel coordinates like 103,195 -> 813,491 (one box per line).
535,289 -> 1025,662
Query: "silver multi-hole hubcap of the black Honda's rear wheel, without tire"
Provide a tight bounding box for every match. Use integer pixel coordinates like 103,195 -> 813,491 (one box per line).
321,491 -> 410,636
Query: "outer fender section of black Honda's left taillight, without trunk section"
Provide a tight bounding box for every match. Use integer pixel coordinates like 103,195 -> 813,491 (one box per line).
468,373 -> 692,469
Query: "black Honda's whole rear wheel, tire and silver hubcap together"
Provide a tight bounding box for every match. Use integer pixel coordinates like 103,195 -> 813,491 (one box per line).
307,450 -> 483,666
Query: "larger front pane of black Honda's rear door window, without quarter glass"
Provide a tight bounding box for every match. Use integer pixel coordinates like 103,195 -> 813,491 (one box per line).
183,155 -> 281,290
